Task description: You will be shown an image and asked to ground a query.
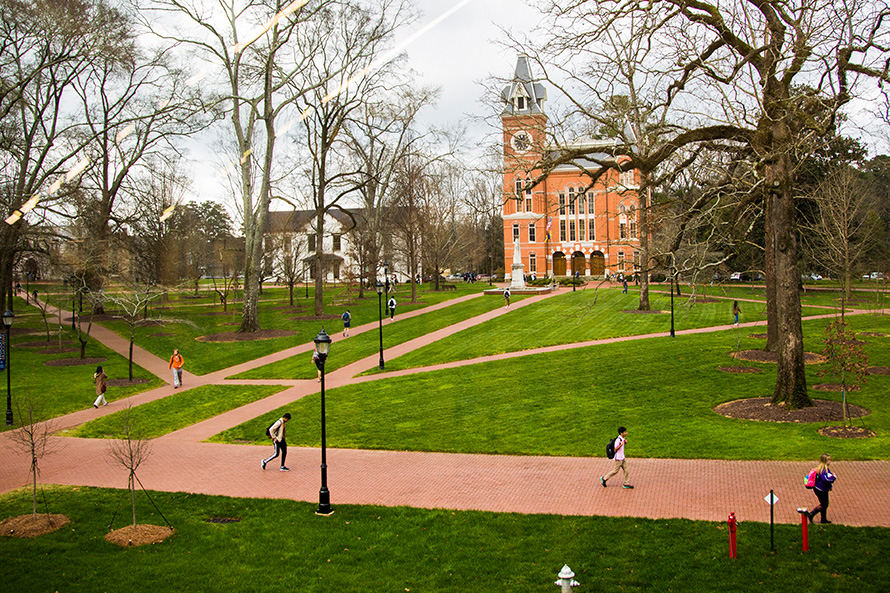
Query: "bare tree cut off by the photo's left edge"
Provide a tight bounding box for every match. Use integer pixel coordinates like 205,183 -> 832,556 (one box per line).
0,0 -> 132,308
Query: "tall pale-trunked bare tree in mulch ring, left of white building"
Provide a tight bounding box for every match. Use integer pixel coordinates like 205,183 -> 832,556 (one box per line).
144,0 -> 336,332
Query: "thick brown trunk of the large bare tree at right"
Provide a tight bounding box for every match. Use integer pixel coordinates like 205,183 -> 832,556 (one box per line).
767,150 -> 812,408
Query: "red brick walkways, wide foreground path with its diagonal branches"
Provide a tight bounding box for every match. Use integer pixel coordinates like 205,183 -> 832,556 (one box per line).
0,295 -> 890,527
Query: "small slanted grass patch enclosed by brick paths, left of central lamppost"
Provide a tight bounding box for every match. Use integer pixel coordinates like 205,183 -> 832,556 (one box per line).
64,385 -> 285,439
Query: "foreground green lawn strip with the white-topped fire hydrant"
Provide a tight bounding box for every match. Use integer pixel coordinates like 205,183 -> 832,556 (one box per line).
0,485 -> 890,593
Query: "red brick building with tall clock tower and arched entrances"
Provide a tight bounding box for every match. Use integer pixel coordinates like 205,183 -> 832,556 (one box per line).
501,56 -> 639,278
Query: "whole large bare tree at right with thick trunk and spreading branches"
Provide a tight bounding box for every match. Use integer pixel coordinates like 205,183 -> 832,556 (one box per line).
512,0 -> 890,408
